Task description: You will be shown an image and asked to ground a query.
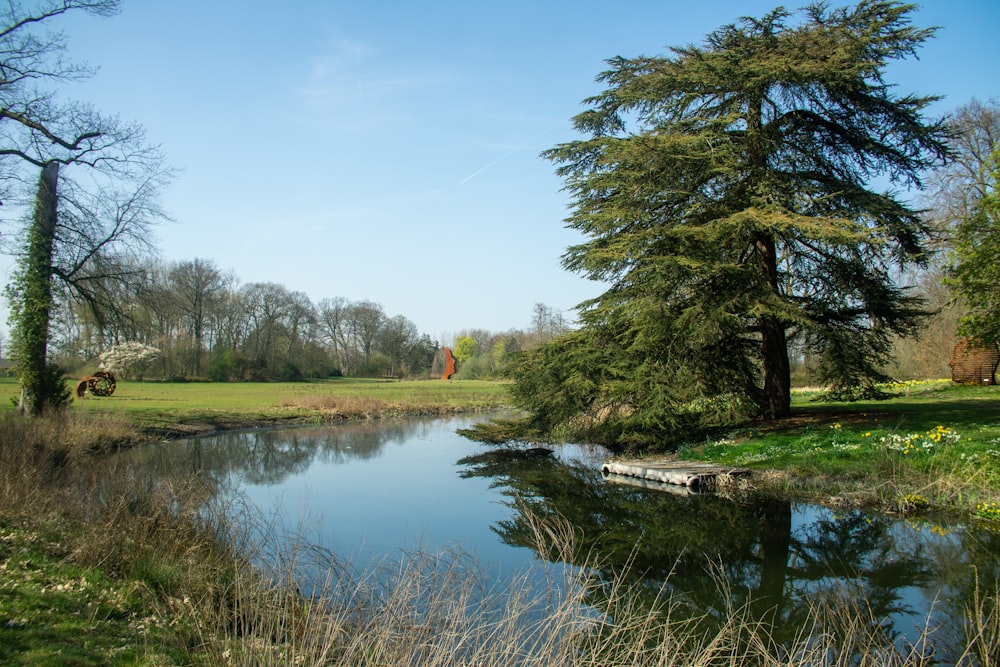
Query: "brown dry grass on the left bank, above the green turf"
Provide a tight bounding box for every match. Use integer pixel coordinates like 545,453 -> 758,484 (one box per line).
0,414 -> 229,601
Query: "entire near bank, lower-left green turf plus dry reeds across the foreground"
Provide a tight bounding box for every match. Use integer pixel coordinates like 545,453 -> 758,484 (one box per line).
0,404 -> 1000,667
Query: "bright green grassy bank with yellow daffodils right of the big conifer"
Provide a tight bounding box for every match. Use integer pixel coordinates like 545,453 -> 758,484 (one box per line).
679,381 -> 1000,528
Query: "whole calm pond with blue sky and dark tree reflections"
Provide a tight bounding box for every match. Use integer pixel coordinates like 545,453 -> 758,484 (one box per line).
140,417 -> 1000,663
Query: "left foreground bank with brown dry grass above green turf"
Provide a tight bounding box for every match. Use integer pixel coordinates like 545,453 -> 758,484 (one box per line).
0,412 -> 232,665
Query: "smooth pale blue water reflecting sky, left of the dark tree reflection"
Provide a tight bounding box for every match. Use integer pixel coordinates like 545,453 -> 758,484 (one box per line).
136,418 -> 548,569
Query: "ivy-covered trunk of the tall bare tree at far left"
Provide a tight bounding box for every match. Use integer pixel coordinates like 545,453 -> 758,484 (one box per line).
16,162 -> 59,416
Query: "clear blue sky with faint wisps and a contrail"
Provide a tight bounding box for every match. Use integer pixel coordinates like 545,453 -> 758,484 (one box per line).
0,0 -> 1000,343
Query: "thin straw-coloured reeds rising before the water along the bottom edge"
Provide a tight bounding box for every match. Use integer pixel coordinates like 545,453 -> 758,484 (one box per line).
182,526 -> 1000,667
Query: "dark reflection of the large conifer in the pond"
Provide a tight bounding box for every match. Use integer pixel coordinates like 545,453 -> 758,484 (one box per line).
460,451 -> 1000,661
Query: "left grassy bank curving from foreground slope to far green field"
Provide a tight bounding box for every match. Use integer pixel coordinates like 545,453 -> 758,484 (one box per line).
0,378 -> 504,665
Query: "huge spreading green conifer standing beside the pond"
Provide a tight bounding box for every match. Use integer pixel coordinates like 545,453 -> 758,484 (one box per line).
504,1 -> 948,445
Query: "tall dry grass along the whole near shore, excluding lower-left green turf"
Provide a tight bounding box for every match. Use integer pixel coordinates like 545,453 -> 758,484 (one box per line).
0,416 -> 1000,667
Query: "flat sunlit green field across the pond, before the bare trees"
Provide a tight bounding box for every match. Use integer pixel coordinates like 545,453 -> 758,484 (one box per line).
0,378 -> 505,435
